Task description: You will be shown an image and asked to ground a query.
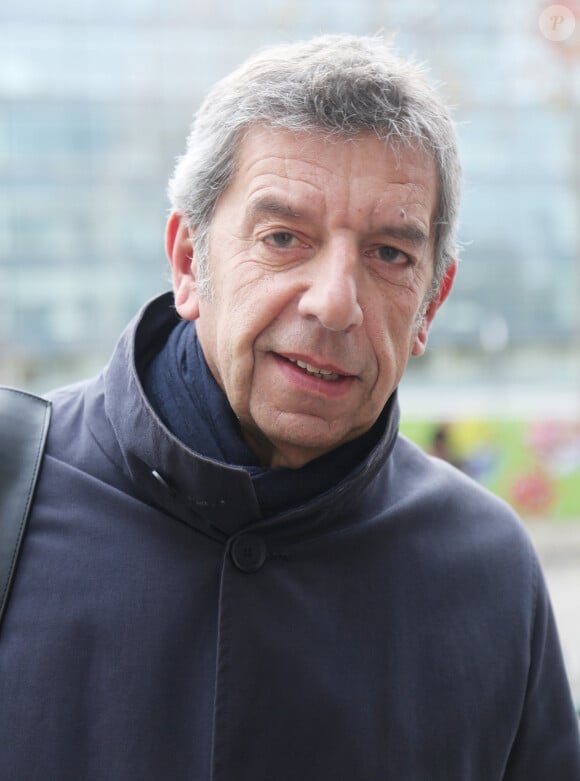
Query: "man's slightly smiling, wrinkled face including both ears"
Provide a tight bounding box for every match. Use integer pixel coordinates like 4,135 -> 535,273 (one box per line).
167,127 -> 453,468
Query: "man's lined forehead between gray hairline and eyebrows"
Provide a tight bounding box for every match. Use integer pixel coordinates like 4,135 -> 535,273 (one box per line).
224,126 -> 438,222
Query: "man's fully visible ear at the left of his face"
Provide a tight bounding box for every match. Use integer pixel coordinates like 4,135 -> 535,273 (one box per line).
165,211 -> 199,320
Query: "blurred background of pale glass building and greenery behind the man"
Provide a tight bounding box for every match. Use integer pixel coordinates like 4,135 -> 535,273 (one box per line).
0,0 -> 580,703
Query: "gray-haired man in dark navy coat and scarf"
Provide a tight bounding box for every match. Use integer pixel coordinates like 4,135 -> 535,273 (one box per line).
0,36 -> 580,781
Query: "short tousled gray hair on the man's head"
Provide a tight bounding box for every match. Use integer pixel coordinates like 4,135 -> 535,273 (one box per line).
168,35 -> 461,295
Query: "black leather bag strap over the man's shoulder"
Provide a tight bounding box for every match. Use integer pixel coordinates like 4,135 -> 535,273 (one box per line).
0,387 -> 51,624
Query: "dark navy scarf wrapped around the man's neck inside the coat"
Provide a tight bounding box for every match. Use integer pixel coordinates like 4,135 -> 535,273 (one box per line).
143,321 -> 387,516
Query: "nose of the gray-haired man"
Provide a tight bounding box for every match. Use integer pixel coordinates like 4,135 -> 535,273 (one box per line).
298,242 -> 363,331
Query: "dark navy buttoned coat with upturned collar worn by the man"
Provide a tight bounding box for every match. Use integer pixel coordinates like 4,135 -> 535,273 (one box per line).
0,297 -> 580,781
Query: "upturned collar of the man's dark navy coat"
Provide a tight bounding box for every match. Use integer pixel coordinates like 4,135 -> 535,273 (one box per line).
104,293 -> 399,539
